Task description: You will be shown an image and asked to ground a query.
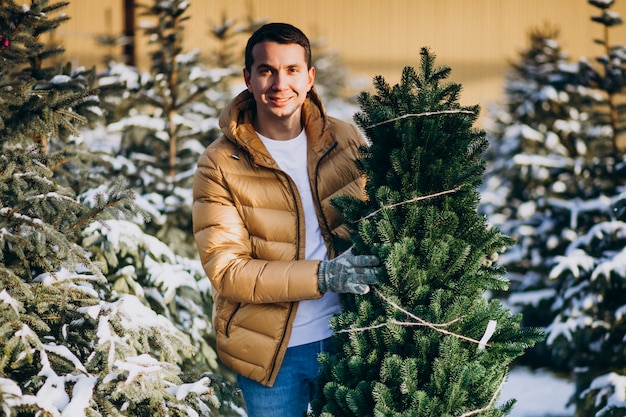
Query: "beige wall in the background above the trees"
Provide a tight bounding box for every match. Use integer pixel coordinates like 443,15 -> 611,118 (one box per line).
58,0 -> 626,122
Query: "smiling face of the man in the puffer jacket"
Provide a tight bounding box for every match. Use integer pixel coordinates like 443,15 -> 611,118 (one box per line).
244,42 -> 315,125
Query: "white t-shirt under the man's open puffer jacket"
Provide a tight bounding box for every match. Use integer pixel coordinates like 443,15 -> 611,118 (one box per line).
257,130 -> 341,347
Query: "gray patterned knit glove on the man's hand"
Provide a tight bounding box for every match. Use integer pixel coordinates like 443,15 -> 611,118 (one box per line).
317,248 -> 380,294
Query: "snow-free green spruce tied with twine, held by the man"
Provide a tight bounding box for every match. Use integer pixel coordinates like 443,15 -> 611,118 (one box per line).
313,49 -> 542,417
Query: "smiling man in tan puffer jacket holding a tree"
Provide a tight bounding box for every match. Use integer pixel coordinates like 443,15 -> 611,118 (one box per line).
193,23 -> 378,417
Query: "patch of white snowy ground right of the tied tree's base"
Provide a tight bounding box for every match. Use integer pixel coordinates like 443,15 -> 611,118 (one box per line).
500,367 -> 574,417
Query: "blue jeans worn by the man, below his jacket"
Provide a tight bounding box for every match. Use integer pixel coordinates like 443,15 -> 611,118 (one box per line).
237,338 -> 331,417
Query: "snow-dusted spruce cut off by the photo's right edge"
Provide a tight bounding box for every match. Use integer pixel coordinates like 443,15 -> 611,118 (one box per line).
547,0 -> 626,417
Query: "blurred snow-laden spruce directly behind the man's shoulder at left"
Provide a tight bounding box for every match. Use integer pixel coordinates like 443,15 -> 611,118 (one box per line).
100,0 -> 239,257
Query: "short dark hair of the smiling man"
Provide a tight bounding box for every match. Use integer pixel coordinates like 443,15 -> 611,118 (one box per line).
245,23 -> 312,71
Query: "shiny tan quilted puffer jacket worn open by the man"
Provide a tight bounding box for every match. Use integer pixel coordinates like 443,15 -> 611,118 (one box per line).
193,90 -> 365,386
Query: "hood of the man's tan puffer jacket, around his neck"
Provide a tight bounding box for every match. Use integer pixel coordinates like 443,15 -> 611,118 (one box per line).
219,87 -> 329,165
